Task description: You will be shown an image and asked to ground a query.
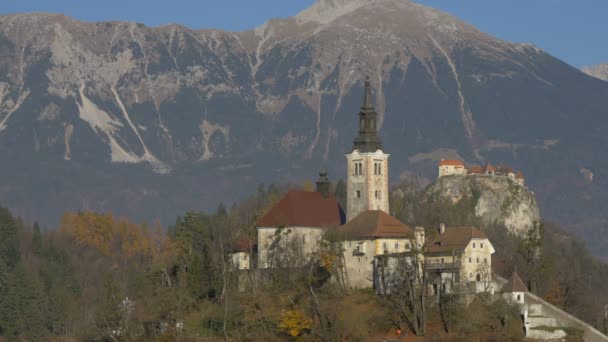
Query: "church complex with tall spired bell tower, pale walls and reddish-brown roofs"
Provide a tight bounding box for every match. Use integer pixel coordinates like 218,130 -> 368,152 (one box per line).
239,79 -> 494,293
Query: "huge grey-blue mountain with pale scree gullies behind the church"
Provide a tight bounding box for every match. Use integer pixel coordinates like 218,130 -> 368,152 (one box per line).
0,0 -> 608,256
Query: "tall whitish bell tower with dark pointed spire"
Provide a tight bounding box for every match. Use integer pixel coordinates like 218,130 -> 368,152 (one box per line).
346,78 -> 389,222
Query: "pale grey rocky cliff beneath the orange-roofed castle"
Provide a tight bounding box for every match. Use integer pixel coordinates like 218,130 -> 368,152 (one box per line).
426,174 -> 541,237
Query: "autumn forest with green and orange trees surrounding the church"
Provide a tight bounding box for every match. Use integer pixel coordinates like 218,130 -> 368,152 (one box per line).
0,182 -> 608,341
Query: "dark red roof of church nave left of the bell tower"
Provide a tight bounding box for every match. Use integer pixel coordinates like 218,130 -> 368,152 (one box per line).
256,191 -> 345,228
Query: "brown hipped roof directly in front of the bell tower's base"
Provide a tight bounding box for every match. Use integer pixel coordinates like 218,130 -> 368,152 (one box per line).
336,210 -> 414,240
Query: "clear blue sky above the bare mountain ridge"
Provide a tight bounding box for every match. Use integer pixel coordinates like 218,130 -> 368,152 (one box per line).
0,0 -> 608,67
